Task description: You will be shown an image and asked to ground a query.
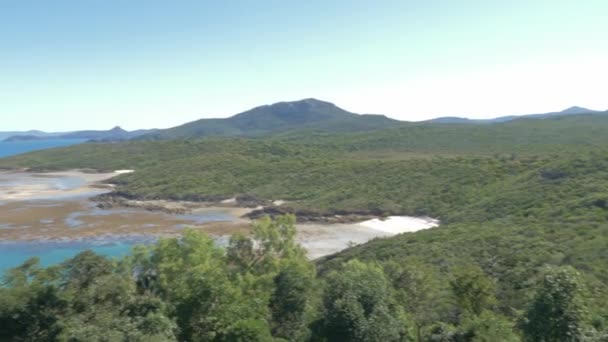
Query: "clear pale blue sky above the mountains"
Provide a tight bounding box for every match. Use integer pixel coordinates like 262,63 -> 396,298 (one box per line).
0,0 -> 608,131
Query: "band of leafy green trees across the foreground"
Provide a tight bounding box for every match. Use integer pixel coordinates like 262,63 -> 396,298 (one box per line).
0,216 -> 607,342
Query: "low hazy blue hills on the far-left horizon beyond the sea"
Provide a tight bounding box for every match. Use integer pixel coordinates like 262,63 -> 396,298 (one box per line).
4,126 -> 155,141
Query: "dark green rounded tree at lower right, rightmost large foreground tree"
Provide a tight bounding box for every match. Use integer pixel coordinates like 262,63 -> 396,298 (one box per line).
524,266 -> 591,342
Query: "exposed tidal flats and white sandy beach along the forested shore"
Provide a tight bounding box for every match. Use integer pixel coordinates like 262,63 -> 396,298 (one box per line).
0,170 -> 439,259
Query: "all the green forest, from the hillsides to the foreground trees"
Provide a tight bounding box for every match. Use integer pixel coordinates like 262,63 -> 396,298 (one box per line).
0,115 -> 608,341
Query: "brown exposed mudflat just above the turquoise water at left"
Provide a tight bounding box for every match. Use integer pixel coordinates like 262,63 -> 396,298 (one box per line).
0,200 -> 249,241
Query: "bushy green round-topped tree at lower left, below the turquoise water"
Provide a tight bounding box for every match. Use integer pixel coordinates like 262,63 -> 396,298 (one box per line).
56,251 -> 176,342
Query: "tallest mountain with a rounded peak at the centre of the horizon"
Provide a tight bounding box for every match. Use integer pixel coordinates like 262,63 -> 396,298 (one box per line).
136,99 -> 400,140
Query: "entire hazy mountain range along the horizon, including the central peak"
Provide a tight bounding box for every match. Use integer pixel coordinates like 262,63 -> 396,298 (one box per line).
0,98 -> 608,141
